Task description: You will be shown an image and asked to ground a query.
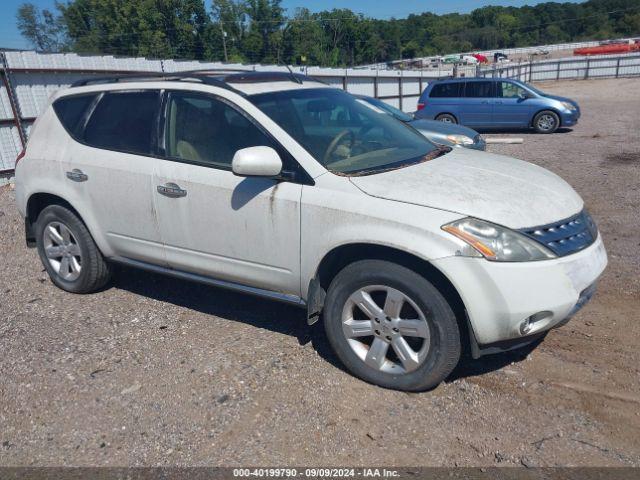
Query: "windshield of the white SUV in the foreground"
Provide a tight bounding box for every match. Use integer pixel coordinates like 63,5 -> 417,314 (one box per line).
249,88 -> 448,175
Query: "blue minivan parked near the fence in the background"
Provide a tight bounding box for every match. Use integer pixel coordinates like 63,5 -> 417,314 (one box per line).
416,78 -> 580,133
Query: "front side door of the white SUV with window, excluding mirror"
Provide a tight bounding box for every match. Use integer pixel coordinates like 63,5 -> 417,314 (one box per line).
154,92 -> 302,295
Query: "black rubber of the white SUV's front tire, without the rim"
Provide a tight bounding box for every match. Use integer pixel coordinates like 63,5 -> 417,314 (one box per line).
323,260 -> 461,391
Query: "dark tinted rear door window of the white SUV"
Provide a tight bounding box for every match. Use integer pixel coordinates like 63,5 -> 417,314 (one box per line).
84,91 -> 159,155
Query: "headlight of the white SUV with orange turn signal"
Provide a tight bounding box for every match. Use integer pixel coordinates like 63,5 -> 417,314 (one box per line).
442,218 -> 555,262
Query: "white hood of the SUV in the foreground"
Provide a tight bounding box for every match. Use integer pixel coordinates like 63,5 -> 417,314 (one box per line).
350,148 -> 583,229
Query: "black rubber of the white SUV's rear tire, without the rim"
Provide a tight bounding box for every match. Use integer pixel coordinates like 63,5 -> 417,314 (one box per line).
35,205 -> 111,293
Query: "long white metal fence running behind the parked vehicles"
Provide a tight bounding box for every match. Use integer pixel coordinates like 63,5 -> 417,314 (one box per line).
0,51 -> 640,175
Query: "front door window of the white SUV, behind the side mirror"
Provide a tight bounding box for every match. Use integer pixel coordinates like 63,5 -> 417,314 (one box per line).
165,92 -> 273,169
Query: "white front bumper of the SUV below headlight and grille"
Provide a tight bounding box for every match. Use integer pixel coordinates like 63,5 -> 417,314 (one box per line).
433,232 -> 607,347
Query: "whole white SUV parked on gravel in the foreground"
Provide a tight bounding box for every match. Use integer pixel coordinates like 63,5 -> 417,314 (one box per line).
16,72 -> 607,391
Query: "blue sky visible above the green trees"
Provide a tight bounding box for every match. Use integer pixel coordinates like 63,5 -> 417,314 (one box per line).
0,0 -> 580,48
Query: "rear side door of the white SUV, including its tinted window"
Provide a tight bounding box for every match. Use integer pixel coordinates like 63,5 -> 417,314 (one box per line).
56,90 -> 164,263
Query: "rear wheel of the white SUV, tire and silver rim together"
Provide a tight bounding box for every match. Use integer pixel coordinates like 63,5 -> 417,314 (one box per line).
35,205 -> 111,293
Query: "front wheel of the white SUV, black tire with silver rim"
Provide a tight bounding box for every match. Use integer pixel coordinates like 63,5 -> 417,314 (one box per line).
323,260 -> 461,391
